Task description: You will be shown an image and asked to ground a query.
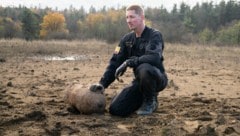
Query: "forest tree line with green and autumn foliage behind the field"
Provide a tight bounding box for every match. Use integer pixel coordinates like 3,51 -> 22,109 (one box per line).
0,0 -> 240,45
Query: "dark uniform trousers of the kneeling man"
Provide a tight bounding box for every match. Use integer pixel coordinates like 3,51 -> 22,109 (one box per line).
109,63 -> 168,116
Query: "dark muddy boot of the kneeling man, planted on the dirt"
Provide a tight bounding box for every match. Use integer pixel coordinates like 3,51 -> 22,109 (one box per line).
136,94 -> 158,115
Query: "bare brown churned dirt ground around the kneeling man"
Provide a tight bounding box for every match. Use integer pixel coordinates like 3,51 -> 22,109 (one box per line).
0,41 -> 240,136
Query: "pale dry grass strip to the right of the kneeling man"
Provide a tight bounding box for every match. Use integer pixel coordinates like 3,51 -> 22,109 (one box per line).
164,44 -> 240,63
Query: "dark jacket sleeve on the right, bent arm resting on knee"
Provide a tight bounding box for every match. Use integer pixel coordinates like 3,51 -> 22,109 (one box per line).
138,31 -> 164,69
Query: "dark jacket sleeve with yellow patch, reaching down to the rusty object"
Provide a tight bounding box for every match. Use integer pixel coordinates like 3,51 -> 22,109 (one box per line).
100,39 -> 127,88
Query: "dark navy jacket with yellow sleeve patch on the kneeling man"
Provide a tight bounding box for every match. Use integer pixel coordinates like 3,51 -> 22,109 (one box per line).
100,26 -> 165,88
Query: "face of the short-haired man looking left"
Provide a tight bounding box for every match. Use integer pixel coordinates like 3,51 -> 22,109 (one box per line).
126,10 -> 143,31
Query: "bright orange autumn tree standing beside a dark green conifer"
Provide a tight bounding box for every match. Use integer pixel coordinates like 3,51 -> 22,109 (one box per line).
40,12 -> 68,39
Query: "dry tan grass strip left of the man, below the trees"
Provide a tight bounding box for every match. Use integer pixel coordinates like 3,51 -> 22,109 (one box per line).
0,39 -> 114,58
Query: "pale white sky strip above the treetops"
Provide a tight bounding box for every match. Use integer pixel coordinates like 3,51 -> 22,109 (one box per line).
0,0 -> 232,10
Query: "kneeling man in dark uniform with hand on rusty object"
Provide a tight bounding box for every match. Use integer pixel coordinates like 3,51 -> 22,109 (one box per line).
91,5 -> 168,116
